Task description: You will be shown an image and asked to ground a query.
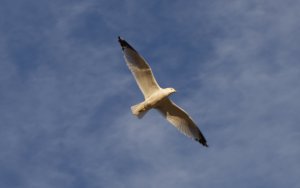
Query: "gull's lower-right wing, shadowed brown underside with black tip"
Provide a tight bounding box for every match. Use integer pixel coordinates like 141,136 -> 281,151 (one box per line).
156,99 -> 207,146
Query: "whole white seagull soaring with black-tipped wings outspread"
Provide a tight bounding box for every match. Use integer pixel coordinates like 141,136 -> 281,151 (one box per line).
118,36 -> 208,147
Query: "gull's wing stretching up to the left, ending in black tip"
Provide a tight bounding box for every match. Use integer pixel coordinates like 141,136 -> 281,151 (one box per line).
119,37 -> 160,98
